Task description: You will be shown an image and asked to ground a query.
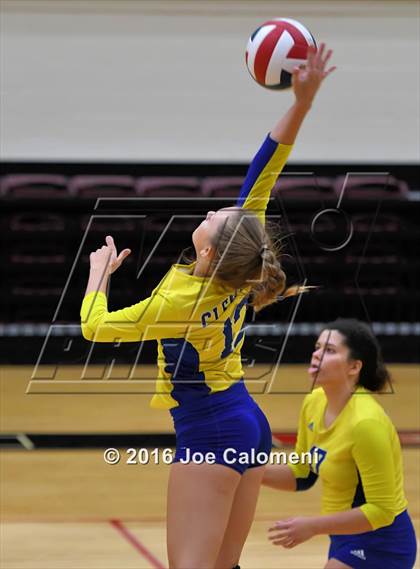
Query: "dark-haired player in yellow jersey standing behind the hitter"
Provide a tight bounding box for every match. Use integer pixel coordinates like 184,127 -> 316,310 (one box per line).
263,319 -> 416,569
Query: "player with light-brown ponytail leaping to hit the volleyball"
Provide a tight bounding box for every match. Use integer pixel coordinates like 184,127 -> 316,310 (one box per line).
81,45 -> 334,569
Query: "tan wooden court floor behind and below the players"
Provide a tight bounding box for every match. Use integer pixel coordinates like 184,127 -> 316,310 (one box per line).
0,366 -> 420,569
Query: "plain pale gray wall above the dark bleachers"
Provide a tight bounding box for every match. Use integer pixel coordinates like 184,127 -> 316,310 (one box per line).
0,0 -> 420,162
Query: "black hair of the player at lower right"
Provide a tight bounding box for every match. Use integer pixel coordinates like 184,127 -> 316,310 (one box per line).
323,318 -> 391,391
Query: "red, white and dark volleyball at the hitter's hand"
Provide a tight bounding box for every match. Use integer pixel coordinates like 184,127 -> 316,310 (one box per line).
245,18 -> 316,89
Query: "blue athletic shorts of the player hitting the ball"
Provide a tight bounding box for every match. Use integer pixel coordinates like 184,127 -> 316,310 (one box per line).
171,380 -> 272,474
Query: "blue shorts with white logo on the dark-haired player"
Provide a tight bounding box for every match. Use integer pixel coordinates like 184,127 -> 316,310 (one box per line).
328,510 -> 417,569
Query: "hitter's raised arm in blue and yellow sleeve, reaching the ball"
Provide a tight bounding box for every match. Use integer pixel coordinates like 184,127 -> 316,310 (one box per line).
237,44 -> 335,224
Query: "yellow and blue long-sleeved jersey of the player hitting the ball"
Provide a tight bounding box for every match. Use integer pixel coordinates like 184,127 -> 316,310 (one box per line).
80,136 -> 292,409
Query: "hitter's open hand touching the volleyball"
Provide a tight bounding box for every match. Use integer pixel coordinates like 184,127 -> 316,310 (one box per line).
292,43 -> 336,105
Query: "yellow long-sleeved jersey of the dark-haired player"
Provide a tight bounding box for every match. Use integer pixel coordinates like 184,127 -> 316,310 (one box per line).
289,387 -> 407,529
